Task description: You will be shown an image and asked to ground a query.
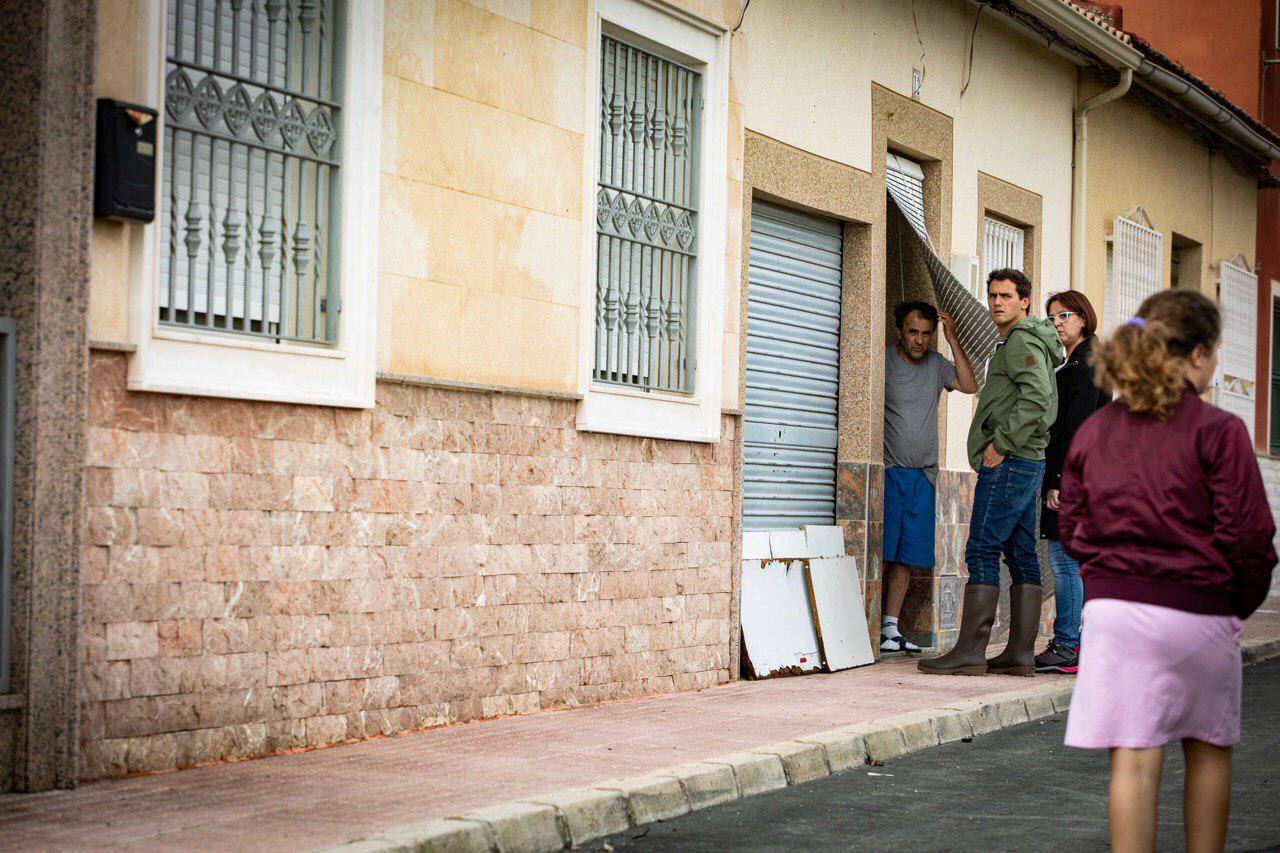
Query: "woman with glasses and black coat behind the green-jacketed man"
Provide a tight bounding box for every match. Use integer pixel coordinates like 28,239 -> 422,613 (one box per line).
1036,291 -> 1111,675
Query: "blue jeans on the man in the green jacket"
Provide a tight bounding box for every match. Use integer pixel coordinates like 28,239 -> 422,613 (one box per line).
964,456 -> 1044,587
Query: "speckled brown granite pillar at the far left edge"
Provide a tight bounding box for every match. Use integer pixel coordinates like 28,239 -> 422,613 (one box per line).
0,0 -> 96,790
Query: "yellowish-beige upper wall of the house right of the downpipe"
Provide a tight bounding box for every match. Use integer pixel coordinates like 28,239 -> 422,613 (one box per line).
1080,77 -> 1257,316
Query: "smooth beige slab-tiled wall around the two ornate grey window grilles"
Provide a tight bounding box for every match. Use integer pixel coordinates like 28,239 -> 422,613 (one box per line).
90,0 -> 741,407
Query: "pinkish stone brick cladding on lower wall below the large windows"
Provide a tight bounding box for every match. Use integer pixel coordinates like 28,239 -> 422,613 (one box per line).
81,351 -> 736,780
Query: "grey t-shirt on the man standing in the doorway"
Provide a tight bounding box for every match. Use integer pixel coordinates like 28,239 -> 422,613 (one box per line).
884,345 -> 956,480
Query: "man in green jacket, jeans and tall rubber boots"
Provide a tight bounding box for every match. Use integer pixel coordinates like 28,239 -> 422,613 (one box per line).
919,269 -> 1064,675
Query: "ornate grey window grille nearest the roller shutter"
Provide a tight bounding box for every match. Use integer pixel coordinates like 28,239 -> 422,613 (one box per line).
594,36 -> 701,392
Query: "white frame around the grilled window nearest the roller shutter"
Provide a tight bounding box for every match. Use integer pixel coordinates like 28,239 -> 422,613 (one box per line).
577,0 -> 728,442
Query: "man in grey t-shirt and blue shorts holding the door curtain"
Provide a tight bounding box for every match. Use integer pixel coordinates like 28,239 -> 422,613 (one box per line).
881,302 -> 978,652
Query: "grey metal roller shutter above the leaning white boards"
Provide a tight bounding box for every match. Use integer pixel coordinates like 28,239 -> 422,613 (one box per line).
742,201 -> 844,530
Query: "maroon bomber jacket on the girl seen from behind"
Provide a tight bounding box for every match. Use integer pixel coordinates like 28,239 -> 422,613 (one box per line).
1059,384 -> 1276,619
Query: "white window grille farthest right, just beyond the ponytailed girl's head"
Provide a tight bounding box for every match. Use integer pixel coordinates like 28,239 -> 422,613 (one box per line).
1217,261 -> 1258,438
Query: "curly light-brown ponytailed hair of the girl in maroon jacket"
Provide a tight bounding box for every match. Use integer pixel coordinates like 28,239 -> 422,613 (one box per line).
1094,289 -> 1222,420
